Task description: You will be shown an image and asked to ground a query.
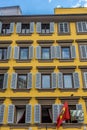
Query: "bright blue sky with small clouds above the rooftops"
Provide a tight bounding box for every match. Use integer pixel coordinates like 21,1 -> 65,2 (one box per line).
0,0 -> 87,14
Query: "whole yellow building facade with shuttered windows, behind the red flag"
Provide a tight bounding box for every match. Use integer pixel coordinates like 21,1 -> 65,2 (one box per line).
0,8 -> 87,130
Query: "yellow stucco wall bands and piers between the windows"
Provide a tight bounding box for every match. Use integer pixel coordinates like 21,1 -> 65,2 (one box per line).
0,8 -> 87,130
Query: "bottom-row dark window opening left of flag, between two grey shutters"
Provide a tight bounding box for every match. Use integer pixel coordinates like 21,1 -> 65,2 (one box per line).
41,105 -> 52,123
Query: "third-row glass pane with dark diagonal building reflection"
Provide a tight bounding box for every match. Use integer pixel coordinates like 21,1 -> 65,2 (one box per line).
18,75 -> 27,89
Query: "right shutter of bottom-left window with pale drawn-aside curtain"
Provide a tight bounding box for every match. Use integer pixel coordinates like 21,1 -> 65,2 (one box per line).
25,105 -> 32,123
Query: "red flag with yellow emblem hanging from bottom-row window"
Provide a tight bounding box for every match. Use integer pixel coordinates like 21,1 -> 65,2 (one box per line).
57,102 -> 70,128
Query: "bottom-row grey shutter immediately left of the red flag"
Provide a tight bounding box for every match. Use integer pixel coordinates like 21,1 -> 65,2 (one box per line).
52,104 -> 59,123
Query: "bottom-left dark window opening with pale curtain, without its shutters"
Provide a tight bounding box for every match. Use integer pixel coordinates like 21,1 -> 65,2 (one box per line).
15,106 -> 26,124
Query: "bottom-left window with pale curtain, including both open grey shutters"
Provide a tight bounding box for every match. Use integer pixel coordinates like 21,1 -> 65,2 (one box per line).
8,104 -> 31,124
